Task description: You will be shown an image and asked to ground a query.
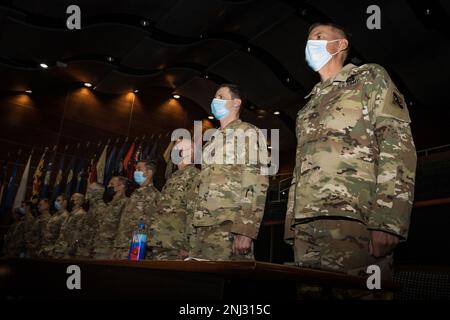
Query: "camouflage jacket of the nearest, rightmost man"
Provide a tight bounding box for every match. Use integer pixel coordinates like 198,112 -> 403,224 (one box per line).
285,64 -> 417,240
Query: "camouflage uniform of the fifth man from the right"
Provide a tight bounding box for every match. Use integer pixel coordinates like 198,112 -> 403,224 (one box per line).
93,195 -> 128,260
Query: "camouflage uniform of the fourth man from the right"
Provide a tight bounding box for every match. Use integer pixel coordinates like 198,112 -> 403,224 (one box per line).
114,184 -> 159,259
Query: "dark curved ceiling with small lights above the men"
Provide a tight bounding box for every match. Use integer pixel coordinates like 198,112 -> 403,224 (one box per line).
0,0 -> 450,152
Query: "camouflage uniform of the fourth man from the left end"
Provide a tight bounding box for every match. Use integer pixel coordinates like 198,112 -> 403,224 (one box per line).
53,208 -> 86,258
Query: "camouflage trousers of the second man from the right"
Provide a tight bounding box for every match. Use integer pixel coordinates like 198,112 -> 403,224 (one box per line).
189,221 -> 255,261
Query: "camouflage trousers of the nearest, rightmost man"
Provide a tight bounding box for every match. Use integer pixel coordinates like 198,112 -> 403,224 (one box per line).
294,219 -> 393,299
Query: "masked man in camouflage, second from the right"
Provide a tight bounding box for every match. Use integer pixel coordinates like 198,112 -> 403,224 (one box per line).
189,84 -> 268,260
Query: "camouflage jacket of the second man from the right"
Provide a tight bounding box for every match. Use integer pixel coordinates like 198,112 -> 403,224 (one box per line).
192,119 -> 268,239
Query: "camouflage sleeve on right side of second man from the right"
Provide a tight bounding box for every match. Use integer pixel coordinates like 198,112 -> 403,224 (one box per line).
231,129 -> 269,239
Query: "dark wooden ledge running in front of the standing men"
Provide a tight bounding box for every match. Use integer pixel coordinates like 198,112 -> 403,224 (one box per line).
0,259 -> 399,291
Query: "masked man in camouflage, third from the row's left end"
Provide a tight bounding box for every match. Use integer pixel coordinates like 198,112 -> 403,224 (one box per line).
39,194 -> 69,258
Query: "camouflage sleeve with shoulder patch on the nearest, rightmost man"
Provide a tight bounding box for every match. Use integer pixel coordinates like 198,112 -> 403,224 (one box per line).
368,67 -> 417,240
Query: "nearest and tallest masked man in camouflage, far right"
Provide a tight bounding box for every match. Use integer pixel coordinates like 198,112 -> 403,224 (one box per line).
285,24 -> 416,292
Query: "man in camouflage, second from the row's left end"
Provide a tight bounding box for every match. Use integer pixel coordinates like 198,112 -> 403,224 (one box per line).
26,199 -> 52,258
